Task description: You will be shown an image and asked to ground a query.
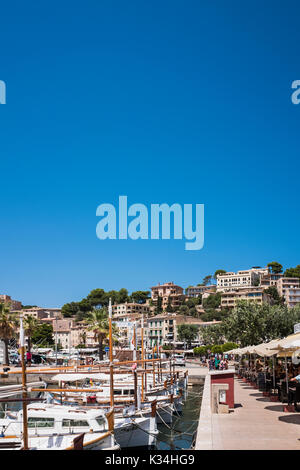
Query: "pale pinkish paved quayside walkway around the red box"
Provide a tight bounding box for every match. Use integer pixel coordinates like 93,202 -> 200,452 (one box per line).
195,375 -> 300,450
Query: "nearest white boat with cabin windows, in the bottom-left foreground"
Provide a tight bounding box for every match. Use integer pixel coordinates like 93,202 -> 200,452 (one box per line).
0,404 -> 120,450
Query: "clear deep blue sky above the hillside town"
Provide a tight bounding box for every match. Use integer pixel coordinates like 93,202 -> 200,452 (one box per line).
0,0 -> 300,307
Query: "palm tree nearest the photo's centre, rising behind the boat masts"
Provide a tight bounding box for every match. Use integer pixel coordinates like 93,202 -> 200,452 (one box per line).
86,308 -> 117,361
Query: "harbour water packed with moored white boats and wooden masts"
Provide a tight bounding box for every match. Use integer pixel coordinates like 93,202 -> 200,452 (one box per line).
0,302 -> 201,450
